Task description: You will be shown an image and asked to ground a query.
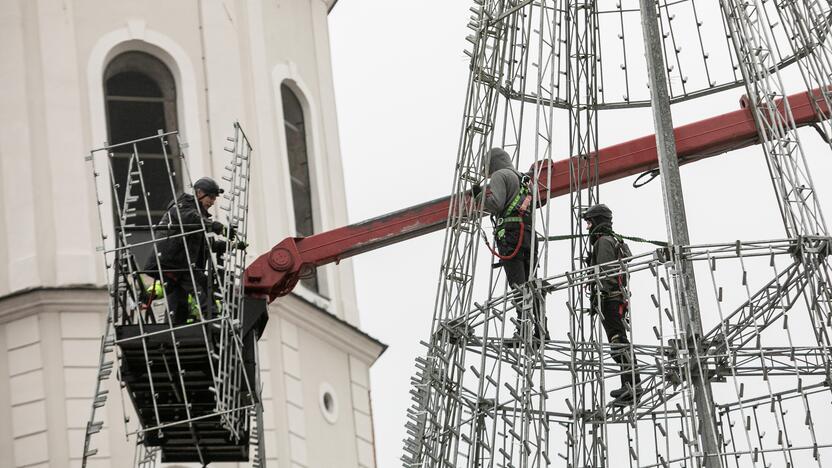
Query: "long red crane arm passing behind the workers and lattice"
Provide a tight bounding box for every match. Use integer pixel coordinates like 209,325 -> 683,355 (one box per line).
244,89 -> 830,301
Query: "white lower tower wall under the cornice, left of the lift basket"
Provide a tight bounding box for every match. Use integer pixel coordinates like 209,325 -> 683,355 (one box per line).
0,290 -> 122,467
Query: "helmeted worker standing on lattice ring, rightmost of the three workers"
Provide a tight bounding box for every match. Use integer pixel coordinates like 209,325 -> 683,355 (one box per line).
582,204 -> 641,400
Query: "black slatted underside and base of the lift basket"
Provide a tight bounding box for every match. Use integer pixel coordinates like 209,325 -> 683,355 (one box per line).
115,299 -> 268,464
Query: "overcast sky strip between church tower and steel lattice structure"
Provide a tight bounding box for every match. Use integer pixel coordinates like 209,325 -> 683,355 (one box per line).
330,0 -> 470,467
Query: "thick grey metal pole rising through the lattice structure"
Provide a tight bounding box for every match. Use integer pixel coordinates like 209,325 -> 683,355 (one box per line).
639,0 -> 721,468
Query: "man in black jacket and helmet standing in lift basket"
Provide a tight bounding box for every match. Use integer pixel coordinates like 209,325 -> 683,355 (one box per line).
144,177 -> 224,325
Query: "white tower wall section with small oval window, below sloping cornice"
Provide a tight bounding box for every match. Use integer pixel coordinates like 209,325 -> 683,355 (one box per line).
269,298 -> 381,468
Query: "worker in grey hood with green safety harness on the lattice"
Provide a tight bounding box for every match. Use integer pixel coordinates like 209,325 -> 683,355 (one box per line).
473,148 -> 549,340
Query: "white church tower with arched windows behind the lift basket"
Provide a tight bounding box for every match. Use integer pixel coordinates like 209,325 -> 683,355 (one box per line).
0,0 -> 384,468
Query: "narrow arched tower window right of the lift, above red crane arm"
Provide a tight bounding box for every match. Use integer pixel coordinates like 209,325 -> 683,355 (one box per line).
280,84 -> 319,292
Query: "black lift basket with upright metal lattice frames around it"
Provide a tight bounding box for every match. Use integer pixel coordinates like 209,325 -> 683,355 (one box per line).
82,124 -> 268,467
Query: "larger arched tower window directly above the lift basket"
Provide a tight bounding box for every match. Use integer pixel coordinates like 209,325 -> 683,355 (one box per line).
104,51 -> 182,224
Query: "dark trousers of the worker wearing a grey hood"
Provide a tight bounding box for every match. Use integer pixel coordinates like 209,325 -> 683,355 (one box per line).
496,224 -> 549,339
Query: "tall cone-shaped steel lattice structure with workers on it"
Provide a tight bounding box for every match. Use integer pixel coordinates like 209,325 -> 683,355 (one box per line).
402,0 -> 832,468
